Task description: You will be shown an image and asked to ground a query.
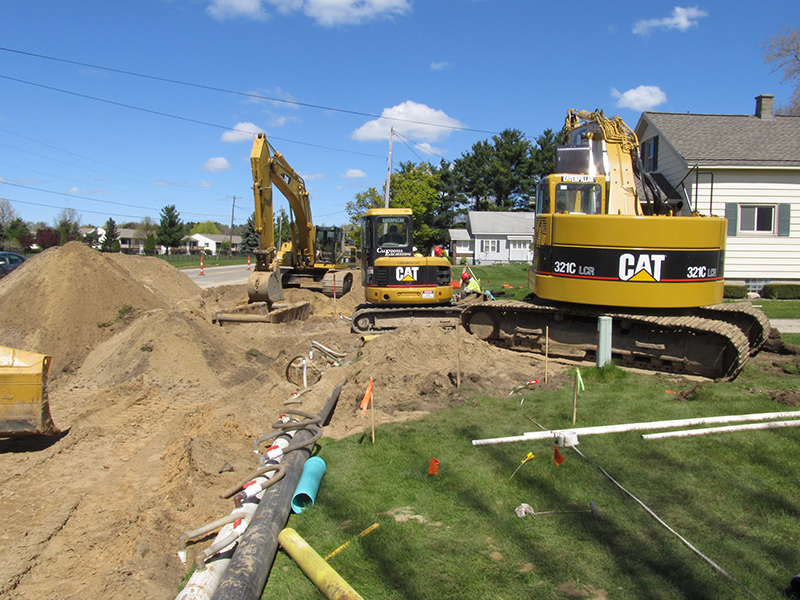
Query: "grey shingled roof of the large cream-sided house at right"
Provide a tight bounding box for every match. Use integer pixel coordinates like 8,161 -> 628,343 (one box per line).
636,112 -> 800,168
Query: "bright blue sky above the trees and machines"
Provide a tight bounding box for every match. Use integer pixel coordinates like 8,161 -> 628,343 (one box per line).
0,0 -> 800,230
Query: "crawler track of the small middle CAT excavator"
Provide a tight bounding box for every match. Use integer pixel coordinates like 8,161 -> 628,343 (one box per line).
350,304 -> 465,335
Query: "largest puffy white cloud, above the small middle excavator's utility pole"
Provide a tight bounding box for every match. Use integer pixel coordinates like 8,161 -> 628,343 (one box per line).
352,100 -> 463,142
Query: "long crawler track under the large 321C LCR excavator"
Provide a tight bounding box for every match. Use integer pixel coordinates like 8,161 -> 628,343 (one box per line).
461,300 -> 769,379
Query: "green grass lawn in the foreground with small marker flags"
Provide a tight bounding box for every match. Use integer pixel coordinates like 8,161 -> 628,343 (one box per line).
263,363 -> 800,600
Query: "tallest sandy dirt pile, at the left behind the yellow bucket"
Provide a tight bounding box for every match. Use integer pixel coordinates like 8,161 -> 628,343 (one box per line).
0,242 -> 199,379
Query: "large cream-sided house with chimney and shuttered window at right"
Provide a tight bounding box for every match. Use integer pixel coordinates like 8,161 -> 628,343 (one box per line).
636,95 -> 800,291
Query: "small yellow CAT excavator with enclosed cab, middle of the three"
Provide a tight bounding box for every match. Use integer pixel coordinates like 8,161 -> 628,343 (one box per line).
351,208 -> 463,333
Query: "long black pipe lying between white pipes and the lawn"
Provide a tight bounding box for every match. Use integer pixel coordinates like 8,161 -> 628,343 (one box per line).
212,378 -> 347,600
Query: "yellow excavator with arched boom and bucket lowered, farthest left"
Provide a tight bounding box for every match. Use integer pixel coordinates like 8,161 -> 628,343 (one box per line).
214,133 -> 357,324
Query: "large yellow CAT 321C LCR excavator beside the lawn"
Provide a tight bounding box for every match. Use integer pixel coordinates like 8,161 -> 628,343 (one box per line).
462,110 -> 769,379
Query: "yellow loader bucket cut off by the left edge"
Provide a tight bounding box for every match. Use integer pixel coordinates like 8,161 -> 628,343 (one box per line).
0,346 -> 58,436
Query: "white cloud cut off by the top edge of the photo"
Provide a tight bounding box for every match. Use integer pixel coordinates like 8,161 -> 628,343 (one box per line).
266,0 -> 411,27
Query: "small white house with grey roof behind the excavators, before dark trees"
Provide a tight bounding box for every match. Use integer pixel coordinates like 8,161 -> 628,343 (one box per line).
449,211 -> 535,265
